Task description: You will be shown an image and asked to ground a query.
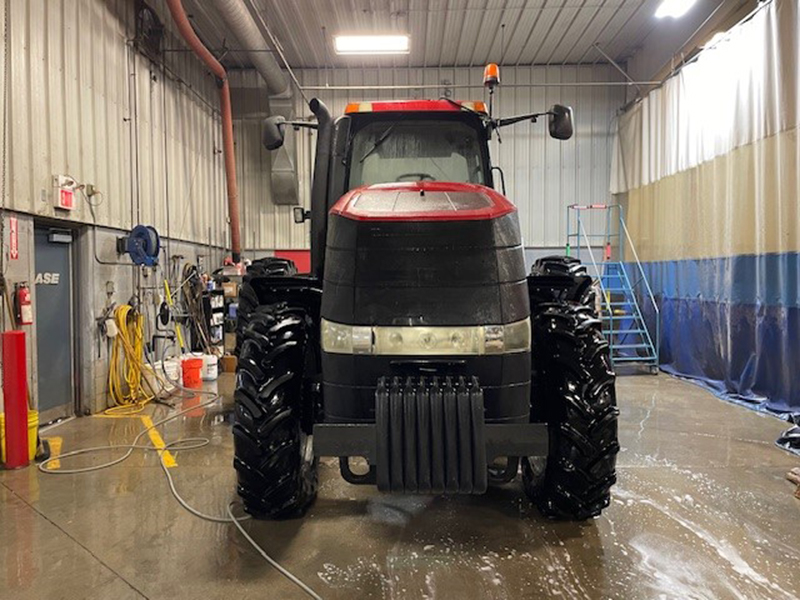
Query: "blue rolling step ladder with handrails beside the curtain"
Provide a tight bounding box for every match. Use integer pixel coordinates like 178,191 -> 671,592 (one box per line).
566,204 -> 660,373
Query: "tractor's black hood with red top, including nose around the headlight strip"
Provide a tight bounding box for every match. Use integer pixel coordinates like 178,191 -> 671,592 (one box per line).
320,181 -> 530,421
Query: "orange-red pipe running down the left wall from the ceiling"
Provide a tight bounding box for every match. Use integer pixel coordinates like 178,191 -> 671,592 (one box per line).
161,0 -> 242,263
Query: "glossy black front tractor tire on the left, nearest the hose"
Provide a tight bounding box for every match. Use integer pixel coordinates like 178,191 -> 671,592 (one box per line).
233,303 -> 318,519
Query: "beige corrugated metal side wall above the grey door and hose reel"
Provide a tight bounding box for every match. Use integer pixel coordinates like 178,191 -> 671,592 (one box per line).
6,0 -> 228,245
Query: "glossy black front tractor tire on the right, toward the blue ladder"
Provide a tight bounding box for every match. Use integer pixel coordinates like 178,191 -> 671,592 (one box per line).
522,302 -> 619,520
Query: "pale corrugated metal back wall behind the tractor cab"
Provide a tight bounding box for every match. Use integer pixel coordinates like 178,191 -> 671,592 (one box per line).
294,65 -> 625,248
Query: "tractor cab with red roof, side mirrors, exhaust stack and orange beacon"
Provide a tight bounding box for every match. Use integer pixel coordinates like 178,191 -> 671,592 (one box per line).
262,74 -> 573,279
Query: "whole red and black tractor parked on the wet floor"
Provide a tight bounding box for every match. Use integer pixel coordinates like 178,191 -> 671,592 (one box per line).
233,67 -> 619,520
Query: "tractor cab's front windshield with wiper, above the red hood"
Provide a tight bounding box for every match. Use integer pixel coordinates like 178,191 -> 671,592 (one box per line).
348,120 -> 486,189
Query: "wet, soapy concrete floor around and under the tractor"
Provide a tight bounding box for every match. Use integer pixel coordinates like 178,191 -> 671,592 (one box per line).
0,375 -> 800,600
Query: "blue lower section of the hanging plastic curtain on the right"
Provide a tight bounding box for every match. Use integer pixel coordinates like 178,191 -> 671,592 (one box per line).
629,253 -> 800,414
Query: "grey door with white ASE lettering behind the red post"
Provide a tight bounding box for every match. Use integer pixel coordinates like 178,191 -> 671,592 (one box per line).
34,227 -> 74,421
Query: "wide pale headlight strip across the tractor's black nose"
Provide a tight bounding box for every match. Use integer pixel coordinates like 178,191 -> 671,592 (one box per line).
322,319 -> 531,356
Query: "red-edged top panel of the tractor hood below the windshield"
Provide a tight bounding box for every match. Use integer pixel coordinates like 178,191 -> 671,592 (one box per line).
331,181 -> 516,221
